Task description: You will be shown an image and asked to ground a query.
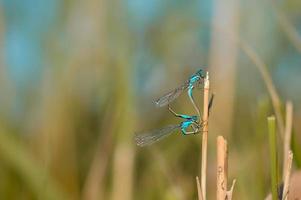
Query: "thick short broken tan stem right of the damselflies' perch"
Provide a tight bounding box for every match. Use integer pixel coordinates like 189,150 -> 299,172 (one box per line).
216,136 -> 228,200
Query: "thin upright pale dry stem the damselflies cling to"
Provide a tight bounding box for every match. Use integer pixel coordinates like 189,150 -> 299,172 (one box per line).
201,72 -> 210,200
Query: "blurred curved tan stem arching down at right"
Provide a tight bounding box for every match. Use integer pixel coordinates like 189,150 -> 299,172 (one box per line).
239,39 -> 284,136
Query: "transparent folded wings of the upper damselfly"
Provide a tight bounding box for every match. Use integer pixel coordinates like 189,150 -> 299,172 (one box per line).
155,81 -> 189,107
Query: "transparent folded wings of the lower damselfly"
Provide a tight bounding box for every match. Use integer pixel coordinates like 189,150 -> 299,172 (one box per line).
135,124 -> 181,147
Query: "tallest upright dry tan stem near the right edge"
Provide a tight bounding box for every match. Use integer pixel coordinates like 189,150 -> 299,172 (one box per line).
282,101 -> 293,180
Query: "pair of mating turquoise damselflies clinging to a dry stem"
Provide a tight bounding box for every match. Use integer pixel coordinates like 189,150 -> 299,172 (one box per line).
135,69 -> 213,146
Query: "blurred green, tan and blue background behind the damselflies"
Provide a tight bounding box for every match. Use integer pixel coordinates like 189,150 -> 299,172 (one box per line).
0,0 -> 301,200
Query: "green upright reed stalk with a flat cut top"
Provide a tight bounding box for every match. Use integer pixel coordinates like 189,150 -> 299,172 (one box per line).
268,116 -> 278,200
